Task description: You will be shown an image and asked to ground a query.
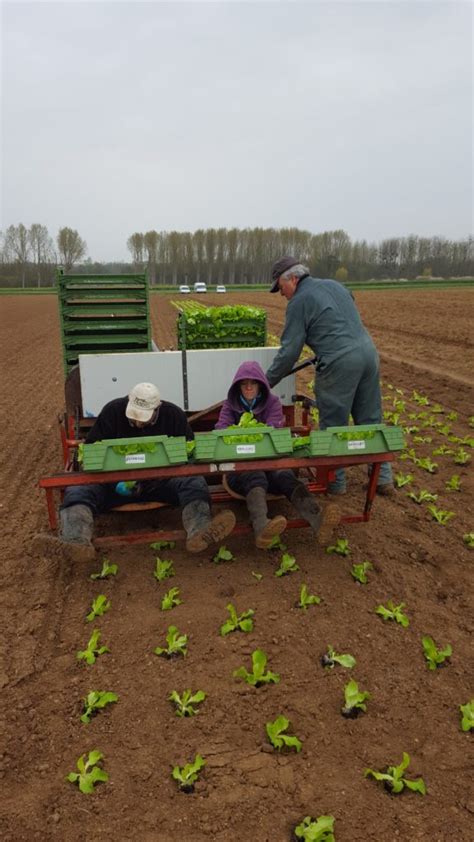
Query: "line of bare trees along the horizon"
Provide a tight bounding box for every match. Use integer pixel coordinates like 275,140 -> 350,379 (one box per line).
0,223 -> 474,287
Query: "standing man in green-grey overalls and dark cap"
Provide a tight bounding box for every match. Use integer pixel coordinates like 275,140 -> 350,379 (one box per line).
266,256 -> 394,495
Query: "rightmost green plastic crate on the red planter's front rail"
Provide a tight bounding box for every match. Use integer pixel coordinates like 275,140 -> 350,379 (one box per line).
309,424 -> 405,456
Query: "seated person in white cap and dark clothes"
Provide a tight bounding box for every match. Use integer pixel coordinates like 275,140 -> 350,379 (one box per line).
38,383 -> 235,561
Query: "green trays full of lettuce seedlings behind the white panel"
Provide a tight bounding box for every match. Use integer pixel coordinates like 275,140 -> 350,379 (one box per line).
177,302 -> 267,351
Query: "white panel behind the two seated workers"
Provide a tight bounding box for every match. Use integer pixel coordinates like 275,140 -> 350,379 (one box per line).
79,348 -> 296,417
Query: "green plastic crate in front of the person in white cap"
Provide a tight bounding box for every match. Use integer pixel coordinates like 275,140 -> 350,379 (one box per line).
82,436 -> 188,471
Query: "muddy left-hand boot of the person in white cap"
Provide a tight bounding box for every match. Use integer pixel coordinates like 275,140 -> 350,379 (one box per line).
33,504 -> 95,562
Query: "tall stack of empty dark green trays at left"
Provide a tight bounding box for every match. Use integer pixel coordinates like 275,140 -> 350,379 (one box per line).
57,270 -> 152,374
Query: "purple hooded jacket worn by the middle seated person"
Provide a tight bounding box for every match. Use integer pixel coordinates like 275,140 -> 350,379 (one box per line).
216,362 -> 285,430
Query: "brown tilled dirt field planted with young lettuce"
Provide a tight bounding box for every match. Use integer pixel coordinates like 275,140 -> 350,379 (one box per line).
0,290 -> 474,842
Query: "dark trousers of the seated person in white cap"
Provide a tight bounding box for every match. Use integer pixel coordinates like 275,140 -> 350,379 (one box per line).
61,477 -> 210,517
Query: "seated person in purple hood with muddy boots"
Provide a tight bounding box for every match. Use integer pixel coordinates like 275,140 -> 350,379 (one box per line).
216,361 -> 340,549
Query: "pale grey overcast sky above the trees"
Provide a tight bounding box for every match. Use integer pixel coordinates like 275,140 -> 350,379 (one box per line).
0,0 -> 473,261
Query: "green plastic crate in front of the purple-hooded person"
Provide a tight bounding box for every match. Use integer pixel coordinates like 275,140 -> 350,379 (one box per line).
194,427 -> 293,462
